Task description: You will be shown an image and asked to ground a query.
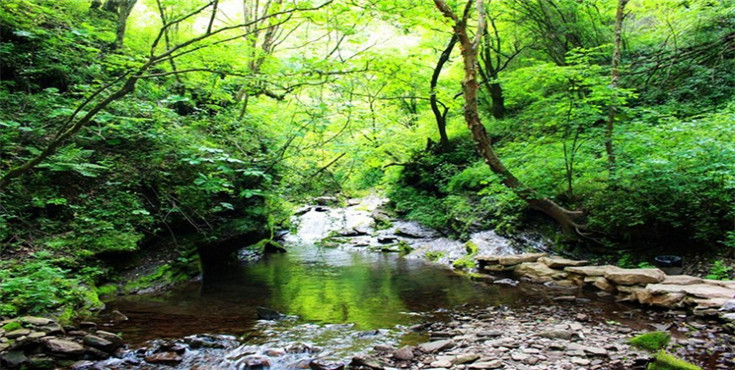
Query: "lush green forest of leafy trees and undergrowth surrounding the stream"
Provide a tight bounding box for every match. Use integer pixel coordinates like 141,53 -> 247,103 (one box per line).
0,0 -> 735,368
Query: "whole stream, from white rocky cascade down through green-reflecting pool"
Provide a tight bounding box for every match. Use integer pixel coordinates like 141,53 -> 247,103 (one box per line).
93,197 -> 684,369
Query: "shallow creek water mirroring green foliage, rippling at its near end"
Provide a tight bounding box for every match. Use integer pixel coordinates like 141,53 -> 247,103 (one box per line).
95,201 -> 652,369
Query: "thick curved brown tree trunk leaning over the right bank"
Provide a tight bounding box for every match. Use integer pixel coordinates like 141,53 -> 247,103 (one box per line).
434,0 -> 582,233
